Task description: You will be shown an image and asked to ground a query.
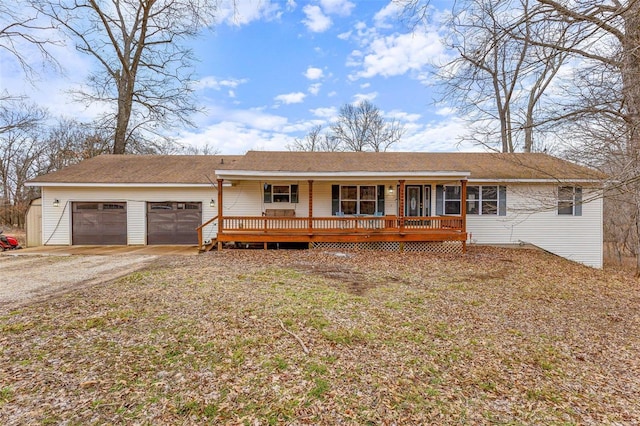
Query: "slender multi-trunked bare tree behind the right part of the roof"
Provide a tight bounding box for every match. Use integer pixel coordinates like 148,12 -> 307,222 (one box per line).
438,0 -> 567,152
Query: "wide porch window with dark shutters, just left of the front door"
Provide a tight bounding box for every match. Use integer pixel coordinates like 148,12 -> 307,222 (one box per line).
331,185 -> 384,215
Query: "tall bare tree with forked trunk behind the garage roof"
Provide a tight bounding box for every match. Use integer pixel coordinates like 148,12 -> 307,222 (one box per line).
32,0 -> 221,154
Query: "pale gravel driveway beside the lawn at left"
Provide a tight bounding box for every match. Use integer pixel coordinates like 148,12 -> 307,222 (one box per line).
0,254 -> 158,310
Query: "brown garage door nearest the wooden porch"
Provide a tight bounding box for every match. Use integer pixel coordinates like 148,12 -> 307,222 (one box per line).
147,201 -> 202,245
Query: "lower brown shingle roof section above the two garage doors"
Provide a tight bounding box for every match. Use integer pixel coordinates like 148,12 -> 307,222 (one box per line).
25,155 -> 242,184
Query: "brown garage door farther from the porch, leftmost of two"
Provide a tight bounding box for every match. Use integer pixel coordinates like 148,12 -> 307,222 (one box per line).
71,201 -> 127,245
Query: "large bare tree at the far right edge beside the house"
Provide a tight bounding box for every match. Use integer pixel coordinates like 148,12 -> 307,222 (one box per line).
520,0 -> 640,277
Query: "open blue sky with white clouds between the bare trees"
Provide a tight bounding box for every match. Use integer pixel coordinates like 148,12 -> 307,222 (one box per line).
0,0 -> 470,154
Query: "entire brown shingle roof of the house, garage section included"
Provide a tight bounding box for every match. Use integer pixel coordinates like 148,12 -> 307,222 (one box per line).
26,151 -> 605,185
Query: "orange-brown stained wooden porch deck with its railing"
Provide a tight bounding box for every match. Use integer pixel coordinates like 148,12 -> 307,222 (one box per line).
198,216 -> 467,250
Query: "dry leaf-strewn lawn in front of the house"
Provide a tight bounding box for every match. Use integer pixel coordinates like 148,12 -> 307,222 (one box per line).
0,248 -> 640,424
